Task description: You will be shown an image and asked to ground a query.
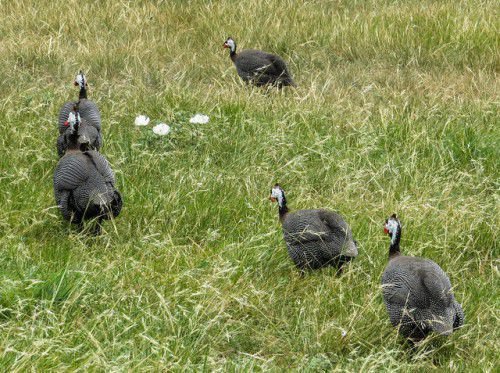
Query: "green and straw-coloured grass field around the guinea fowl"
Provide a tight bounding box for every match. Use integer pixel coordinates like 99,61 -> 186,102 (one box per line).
0,0 -> 500,371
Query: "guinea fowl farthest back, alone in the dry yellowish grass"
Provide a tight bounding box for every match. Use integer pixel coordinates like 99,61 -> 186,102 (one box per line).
224,38 -> 295,88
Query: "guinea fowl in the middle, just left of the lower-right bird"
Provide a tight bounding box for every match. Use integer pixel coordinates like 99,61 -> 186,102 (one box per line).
269,184 -> 358,271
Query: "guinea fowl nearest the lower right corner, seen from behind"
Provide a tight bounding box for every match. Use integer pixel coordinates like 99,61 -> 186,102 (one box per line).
382,214 -> 464,341
